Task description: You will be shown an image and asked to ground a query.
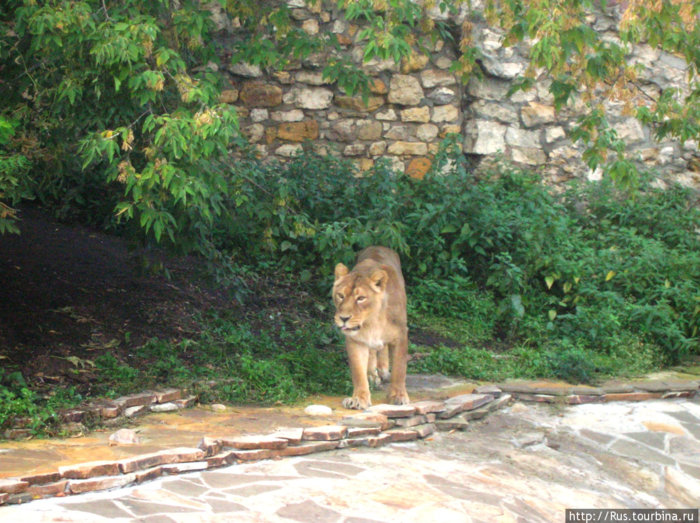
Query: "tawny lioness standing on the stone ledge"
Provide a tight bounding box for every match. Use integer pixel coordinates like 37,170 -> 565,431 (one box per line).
333,247 -> 409,409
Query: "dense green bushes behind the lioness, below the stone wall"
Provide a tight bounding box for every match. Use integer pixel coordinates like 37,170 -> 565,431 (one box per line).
217,144 -> 700,365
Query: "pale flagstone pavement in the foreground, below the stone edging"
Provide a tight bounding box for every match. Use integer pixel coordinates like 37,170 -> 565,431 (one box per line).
0,395 -> 700,523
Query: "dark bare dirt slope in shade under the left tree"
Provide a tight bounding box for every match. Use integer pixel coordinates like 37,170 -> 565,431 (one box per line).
0,207 -> 229,396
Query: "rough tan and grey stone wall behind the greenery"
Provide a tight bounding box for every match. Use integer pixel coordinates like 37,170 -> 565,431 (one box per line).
213,0 -> 700,188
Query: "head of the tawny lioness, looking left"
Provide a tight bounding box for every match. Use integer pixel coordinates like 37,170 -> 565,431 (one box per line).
333,263 -> 389,336
